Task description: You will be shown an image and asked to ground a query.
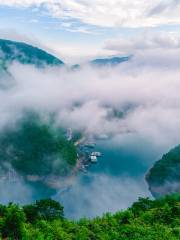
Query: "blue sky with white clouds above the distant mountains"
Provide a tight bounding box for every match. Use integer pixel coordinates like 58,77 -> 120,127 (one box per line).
0,0 -> 180,63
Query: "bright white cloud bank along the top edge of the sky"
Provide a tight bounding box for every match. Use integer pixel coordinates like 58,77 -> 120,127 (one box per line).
0,0 -> 180,28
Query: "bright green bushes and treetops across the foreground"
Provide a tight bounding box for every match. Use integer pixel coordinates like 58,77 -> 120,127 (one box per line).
0,194 -> 180,240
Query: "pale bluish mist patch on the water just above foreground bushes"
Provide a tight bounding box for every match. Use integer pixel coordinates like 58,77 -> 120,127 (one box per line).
54,174 -> 150,219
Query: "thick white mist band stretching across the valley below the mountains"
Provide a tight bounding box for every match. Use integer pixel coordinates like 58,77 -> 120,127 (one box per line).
0,52 -> 180,145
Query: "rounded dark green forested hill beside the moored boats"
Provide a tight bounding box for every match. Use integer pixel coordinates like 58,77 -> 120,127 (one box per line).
0,111 -> 77,177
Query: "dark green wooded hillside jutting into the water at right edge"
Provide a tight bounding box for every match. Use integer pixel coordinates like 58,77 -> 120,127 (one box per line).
146,145 -> 180,197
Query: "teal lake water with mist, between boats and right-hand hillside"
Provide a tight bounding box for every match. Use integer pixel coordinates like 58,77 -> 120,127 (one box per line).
55,133 -> 169,219
